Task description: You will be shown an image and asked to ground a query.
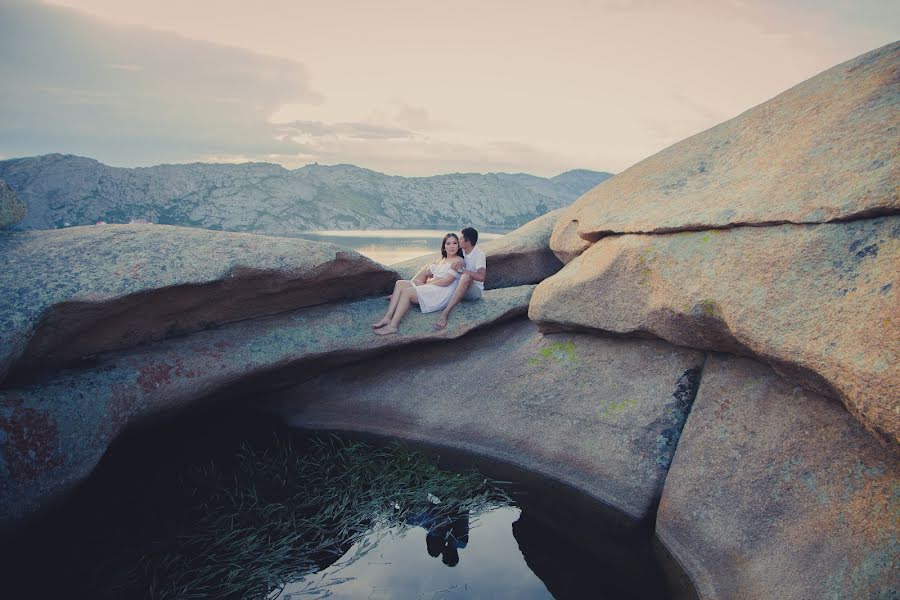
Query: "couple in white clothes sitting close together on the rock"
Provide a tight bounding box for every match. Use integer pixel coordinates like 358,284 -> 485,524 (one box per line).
372,227 -> 486,335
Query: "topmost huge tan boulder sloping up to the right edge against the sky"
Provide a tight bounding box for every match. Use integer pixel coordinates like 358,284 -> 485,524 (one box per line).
550,42 -> 900,262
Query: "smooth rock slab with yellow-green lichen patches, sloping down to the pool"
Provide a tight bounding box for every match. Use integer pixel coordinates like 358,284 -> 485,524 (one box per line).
273,320 -> 705,519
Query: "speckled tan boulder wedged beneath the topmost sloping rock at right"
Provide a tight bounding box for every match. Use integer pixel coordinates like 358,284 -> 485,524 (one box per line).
529,217 -> 900,446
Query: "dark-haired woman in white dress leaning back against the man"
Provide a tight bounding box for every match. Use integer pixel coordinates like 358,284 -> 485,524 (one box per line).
372,233 -> 465,335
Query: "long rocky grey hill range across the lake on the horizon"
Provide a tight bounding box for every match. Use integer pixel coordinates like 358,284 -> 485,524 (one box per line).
0,154 -> 612,235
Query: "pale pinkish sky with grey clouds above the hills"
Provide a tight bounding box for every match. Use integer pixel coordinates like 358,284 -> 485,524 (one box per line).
0,0 -> 900,176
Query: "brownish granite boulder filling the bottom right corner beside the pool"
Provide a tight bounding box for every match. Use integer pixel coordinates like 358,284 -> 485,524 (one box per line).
656,357 -> 900,600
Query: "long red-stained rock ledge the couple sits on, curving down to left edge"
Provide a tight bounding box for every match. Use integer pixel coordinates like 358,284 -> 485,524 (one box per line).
0,286 -> 534,525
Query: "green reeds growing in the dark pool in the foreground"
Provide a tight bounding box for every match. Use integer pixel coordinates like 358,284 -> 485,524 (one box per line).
118,436 -> 509,600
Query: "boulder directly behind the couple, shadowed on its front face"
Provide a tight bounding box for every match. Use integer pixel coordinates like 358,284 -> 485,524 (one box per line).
393,208 -> 563,290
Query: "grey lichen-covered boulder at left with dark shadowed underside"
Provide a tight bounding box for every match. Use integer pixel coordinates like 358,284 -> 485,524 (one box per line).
0,225 -> 396,379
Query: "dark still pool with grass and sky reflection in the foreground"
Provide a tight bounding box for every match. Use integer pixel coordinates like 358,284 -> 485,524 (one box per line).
0,414 -> 692,600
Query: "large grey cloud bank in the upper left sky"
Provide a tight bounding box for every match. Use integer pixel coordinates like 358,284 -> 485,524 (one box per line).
0,0 -> 322,166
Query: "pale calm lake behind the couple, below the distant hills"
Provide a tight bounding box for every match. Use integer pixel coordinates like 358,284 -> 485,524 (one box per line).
296,229 -> 508,265
